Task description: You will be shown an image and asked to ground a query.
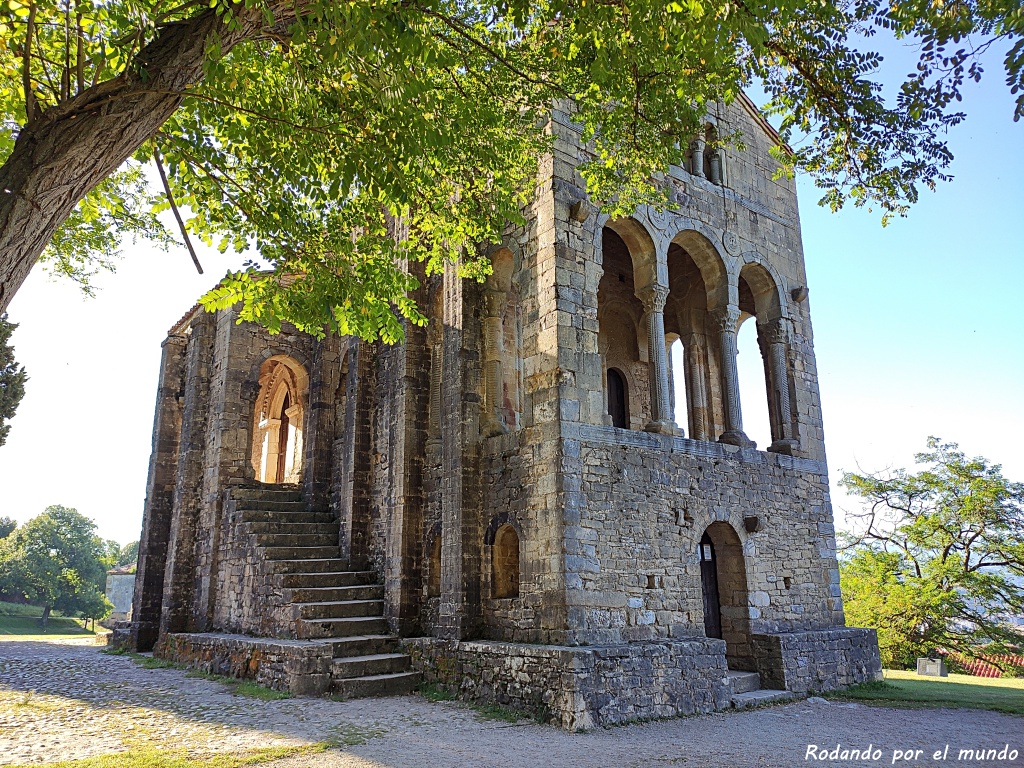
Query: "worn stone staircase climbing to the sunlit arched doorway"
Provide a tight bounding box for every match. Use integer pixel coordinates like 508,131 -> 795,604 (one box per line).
231,486 -> 421,698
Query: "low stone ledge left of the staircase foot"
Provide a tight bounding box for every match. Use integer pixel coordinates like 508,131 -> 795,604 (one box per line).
154,633 -> 334,696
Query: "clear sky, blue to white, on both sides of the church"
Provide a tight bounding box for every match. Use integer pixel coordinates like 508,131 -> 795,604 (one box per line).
0,41 -> 1024,543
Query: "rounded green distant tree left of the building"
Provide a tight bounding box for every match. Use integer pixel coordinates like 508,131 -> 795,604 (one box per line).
0,505 -> 110,626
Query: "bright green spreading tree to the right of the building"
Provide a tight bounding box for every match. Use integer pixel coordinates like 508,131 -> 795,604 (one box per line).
840,437 -> 1024,668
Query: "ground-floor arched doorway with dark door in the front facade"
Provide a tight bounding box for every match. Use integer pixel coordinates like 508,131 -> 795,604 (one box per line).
697,522 -> 754,670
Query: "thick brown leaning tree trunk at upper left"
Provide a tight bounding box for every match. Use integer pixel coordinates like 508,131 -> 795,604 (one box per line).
0,1 -> 295,312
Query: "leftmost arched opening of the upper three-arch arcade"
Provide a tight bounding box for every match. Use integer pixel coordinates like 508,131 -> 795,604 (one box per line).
597,219 -> 656,429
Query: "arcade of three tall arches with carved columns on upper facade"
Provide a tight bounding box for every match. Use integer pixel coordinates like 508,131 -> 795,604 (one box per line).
598,219 -> 797,454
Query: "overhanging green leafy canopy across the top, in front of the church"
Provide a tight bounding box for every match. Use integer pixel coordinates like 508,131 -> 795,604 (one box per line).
0,0 -> 1024,340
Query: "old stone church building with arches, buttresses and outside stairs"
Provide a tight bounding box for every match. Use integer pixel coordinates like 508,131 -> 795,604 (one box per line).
116,94 -> 881,729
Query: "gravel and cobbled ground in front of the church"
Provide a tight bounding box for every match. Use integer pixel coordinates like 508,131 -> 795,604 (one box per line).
0,640 -> 1024,768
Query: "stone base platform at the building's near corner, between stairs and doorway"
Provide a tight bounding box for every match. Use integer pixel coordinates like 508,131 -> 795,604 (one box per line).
402,638 -> 732,731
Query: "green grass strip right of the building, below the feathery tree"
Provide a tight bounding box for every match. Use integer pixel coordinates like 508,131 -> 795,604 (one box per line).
824,670 -> 1024,715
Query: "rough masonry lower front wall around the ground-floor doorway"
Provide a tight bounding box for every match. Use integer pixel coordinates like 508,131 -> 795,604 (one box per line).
567,427 -> 843,643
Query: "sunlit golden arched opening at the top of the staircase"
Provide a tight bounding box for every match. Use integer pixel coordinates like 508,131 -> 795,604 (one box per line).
252,355 -> 308,483
